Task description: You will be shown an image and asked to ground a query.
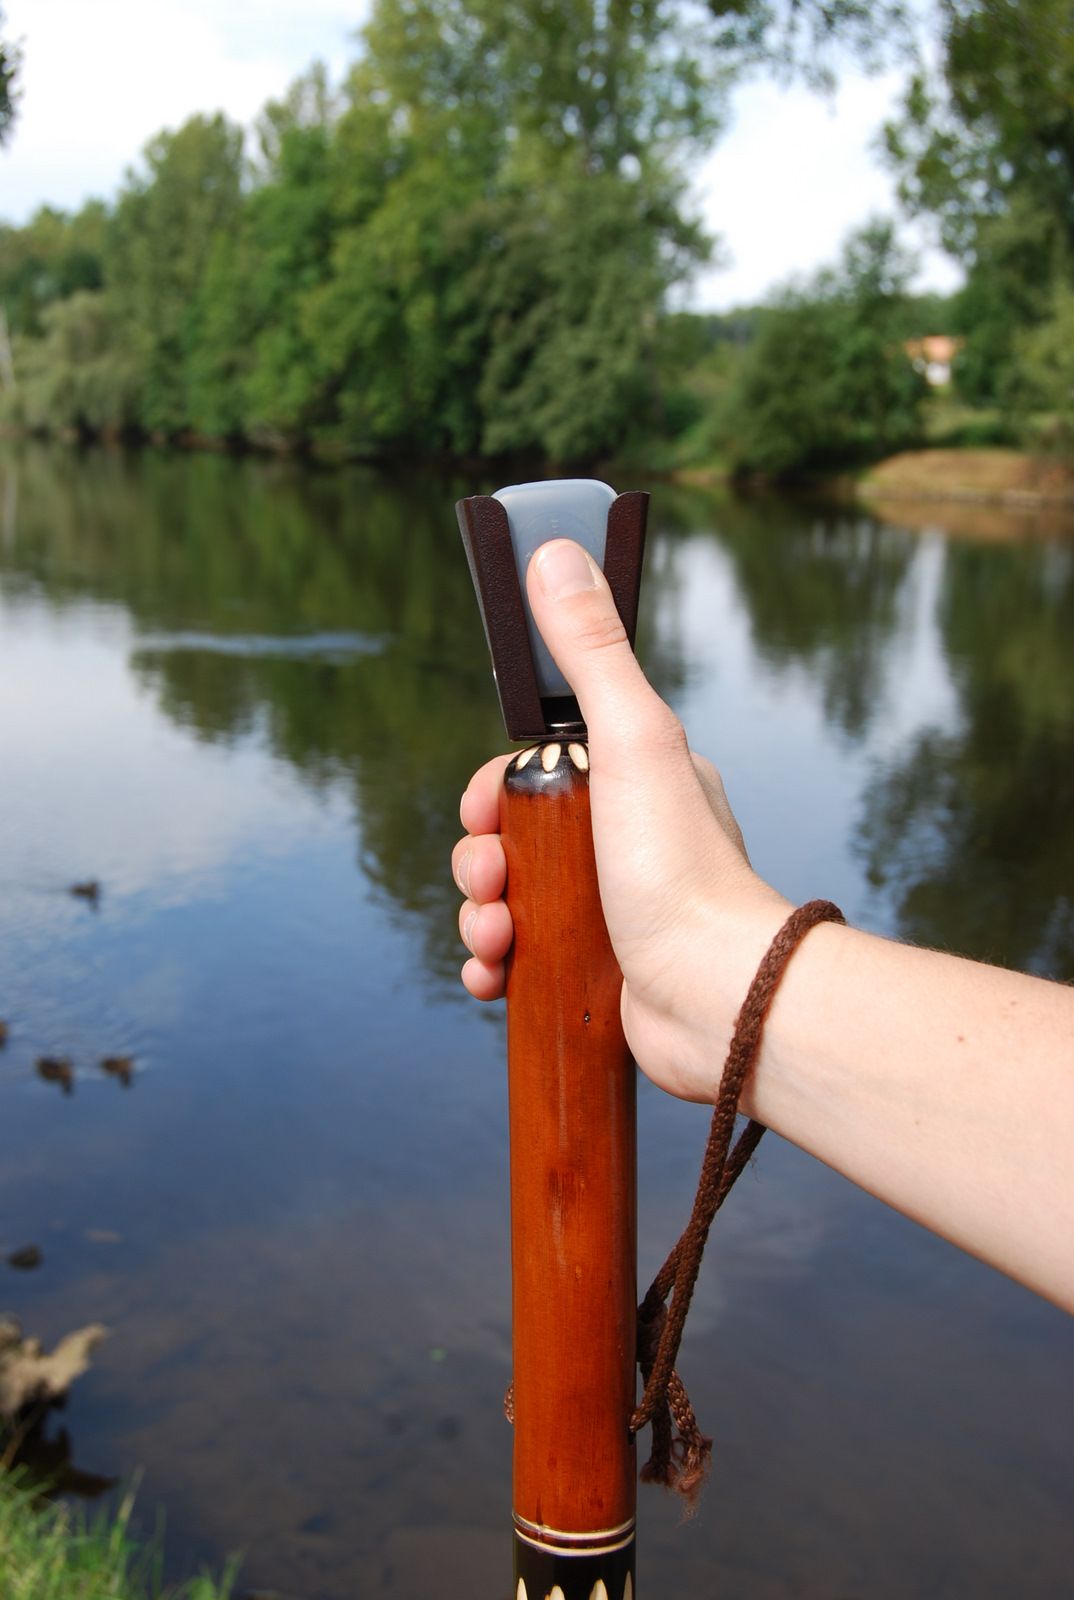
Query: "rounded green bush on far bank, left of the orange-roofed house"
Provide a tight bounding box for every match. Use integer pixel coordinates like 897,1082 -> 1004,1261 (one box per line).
720,224 -> 927,477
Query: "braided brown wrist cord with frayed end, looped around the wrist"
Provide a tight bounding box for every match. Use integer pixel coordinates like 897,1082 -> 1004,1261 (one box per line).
631,901 -> 845,1502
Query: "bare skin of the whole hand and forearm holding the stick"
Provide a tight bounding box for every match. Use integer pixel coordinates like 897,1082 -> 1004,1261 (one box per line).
451,539 -> 1074,1310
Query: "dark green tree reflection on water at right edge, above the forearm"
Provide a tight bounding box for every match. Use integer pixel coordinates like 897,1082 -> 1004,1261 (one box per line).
860,542 -> 1074,979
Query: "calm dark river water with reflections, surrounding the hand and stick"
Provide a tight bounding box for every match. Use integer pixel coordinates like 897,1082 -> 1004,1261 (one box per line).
0,446 -> 1074,1600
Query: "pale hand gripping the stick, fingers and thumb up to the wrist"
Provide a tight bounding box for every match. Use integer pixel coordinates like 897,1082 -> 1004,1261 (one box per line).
451,539 -> 791,1101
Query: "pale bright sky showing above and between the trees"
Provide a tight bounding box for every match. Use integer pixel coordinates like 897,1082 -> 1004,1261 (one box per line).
0,0 -> 959,310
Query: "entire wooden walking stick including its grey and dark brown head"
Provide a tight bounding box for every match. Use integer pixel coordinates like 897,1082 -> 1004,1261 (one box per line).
458,480 -> 648,1600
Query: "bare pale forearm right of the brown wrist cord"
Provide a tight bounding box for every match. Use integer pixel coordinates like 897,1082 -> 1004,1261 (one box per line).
743,925 -> 1074,1310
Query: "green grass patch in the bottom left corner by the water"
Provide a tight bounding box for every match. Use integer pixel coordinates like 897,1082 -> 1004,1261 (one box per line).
0,1472 -> 237,1600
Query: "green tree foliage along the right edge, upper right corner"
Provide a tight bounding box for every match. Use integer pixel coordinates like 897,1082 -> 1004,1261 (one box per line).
887,0 -> 1074,444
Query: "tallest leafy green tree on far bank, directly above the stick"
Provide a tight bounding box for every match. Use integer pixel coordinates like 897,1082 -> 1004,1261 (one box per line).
307,0 -> 720,456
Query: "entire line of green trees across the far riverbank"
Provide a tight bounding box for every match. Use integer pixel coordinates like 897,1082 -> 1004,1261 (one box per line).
0,0 -> 1074,475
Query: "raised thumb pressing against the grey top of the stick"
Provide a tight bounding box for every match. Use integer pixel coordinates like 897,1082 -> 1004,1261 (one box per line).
527,539 -> 672,739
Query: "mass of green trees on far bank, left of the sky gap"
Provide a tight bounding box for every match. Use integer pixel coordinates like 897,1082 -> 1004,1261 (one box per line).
0,0 -> 728,459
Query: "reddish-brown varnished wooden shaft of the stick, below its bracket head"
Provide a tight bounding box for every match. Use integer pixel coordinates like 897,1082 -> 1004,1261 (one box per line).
503,732 -> 637,1600
